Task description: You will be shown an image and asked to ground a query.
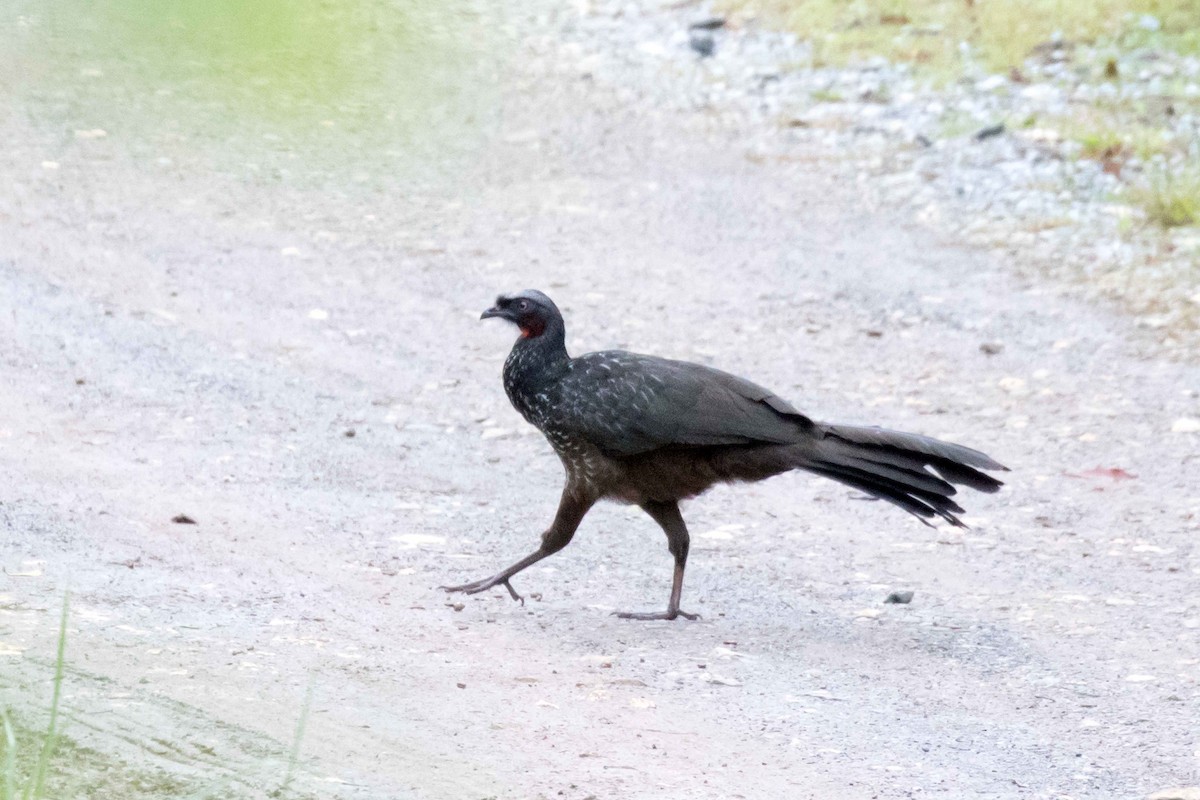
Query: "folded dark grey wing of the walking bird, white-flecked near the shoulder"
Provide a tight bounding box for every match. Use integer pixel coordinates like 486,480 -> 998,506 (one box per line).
556,350 -> 814,456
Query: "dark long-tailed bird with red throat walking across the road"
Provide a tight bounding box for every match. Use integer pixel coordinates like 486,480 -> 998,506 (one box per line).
444,290 -> 1007,619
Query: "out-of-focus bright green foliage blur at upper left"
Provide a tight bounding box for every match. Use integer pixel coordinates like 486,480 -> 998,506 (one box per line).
87,0 -> 452,114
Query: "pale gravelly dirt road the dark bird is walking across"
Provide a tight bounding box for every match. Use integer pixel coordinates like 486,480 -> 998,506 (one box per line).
0,1 -> 1200,800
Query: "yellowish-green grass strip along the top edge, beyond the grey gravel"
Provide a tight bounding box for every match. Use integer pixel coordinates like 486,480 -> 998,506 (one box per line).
722,0 -> 1200,74
